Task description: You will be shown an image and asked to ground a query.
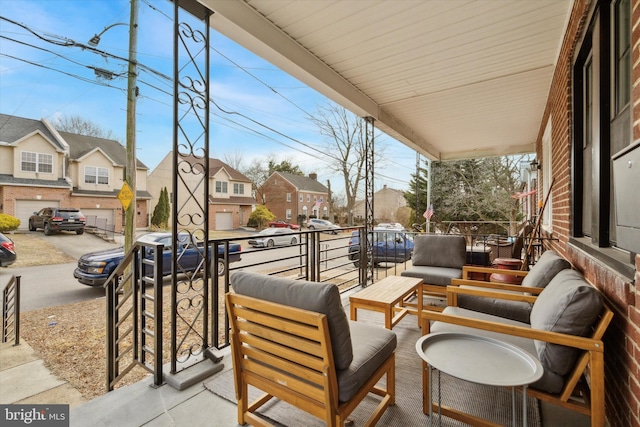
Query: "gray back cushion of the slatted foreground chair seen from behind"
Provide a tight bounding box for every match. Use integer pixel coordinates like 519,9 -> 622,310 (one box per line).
230,271 -> 353,369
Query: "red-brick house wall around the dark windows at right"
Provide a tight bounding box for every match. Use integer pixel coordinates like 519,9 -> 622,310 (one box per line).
537,0 -> 640,427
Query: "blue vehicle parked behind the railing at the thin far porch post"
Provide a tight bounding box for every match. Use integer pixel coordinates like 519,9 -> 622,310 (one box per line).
349,229 -> 413,267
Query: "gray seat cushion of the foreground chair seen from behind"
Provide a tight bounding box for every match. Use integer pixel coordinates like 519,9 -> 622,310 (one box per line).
336,321 -> 397,402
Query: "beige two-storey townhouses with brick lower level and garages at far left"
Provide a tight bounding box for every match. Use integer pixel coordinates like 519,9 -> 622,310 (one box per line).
0,114 -> 151,232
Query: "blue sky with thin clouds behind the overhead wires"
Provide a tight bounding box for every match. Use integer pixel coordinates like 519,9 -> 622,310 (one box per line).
0,0 -> 415,200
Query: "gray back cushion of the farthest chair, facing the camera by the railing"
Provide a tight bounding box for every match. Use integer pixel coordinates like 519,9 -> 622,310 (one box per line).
411,234 -> 467,268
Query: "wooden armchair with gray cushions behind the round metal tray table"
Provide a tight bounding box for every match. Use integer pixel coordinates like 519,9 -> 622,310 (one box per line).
422,270 -> 613,426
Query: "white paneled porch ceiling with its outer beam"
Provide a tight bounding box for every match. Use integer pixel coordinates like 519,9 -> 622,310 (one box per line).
198,0 -> 573,160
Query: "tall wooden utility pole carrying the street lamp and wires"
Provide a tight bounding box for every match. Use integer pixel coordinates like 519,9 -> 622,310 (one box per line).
124,0 -> 138,253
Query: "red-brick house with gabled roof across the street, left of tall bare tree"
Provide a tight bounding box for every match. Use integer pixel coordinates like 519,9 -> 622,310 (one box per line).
262,172 -> 331,223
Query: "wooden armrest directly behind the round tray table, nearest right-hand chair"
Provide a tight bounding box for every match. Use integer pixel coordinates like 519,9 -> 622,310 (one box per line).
421,310 -> 604,353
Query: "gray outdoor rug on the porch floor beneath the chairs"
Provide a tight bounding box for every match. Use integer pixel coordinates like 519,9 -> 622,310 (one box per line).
204,310 -> 541,427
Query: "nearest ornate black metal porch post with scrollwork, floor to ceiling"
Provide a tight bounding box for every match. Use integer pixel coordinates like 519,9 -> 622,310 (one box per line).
171,1 -> 210,373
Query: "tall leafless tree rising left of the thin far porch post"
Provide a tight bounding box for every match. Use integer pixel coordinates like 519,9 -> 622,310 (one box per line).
309,104 -> 384,217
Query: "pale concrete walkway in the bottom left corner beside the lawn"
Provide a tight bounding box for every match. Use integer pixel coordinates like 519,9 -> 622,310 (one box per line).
0,340 -> 85,408
